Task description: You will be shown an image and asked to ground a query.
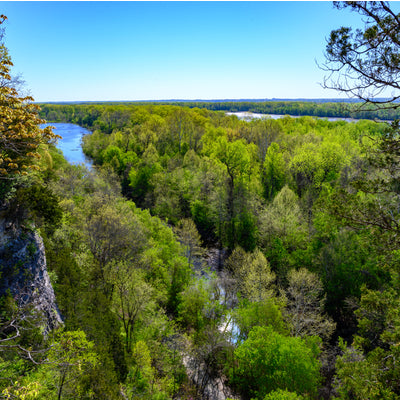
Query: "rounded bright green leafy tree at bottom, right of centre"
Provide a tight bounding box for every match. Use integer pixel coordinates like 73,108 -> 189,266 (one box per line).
231,326 -> 320,399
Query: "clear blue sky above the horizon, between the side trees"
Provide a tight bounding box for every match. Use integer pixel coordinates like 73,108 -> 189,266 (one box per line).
0,1 -> 388,102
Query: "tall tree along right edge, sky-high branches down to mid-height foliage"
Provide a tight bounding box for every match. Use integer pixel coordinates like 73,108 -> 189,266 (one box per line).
325,1 -> 400,255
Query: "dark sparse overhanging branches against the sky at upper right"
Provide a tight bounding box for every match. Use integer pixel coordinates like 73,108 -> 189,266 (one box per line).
323,1 -> 400,108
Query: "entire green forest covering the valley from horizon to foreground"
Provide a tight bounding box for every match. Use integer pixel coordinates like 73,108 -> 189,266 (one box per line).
0,2 -> 400,400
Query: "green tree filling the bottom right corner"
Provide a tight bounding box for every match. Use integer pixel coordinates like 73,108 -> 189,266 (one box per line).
336,287 -> 400,400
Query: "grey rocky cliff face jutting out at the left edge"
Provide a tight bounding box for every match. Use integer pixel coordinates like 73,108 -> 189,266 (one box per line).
0,215 -> 62,334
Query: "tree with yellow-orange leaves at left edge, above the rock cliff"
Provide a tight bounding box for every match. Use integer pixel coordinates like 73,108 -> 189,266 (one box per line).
0,15 -> 59,179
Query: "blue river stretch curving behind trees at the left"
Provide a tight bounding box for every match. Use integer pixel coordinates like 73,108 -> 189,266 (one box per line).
41,122 -> 92,168
